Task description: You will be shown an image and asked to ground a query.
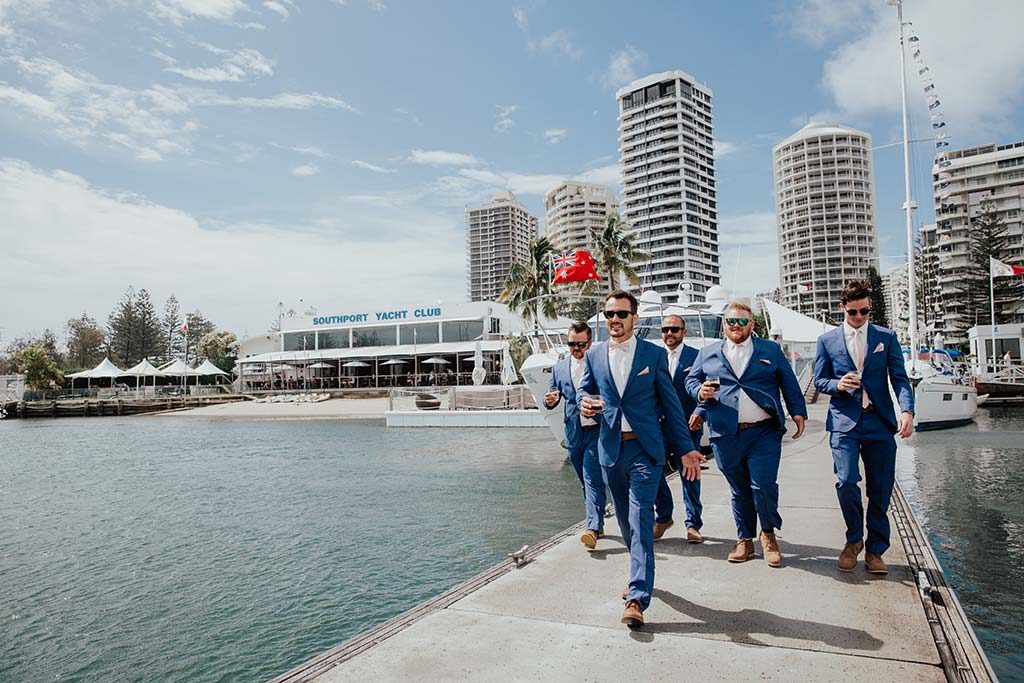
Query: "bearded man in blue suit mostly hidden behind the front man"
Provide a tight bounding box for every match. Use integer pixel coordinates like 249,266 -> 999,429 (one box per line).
654,314 -> 703,543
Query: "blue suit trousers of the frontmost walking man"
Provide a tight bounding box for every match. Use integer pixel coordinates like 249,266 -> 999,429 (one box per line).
604,440 -> 663,609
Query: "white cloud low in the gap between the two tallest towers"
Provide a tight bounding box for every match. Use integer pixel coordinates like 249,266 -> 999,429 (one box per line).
718,211 -> 778,297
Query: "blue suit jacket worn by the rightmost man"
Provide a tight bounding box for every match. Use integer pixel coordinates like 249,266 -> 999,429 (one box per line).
814,323 -> 913,433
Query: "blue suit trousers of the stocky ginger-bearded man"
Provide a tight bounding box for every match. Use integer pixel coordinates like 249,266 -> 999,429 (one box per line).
711,425 -> 782,540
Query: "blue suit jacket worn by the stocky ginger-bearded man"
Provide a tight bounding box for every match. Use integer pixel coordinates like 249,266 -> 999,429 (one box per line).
686,337 -> 807,438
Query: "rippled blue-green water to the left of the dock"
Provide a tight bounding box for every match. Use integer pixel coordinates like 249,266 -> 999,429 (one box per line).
0,418 -> 582,683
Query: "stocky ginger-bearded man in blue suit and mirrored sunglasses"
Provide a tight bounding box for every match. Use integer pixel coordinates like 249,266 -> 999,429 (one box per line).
686,303 -> 807,567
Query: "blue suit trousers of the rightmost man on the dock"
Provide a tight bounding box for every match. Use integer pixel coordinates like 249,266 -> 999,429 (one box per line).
829,412 -> 896,555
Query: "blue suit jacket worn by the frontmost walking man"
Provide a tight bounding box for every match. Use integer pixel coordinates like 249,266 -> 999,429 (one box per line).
577,339 -> 693,467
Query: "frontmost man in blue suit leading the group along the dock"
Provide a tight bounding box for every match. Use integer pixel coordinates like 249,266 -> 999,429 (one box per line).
578,291 -> 702,628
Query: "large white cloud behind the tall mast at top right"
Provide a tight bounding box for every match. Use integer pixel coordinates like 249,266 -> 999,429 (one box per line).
796,0 -> 1024,139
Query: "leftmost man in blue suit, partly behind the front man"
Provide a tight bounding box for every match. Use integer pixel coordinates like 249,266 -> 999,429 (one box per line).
544,323 -> 605,550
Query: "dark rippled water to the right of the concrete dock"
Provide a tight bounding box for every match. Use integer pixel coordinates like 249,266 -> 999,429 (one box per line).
898,407 -> 1024,683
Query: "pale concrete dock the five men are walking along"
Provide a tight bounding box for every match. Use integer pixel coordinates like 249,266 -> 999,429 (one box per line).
274,403 -> 995,683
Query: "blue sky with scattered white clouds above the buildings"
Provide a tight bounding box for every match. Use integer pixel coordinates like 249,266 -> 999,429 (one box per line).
0,0 -> 1024,343
